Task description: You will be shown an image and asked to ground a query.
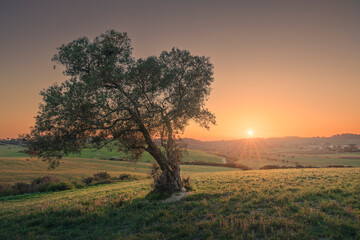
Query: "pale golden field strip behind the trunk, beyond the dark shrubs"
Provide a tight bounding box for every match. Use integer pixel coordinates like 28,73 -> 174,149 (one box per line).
0,157 -> 239,185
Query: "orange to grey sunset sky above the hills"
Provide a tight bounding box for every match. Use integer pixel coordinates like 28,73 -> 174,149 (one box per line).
0,0 -> 360,140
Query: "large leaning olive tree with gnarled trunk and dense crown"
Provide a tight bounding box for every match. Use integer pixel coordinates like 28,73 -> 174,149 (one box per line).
25,30 -> 215,191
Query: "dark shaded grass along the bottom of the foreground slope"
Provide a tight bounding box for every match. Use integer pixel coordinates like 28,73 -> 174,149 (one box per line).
0,192 -> 359,239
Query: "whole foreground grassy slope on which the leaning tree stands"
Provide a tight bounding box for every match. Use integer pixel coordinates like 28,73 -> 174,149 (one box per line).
0,166 -> 360,239
